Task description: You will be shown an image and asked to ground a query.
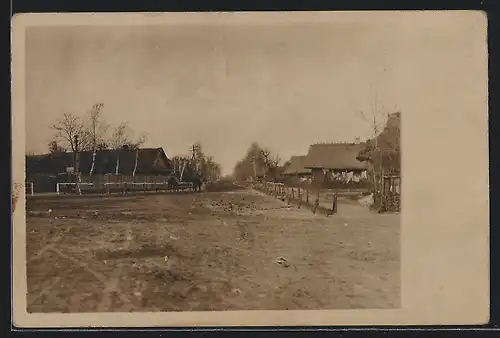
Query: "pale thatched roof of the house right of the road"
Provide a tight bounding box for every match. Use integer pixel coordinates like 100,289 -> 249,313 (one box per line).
304,143 -> 367,170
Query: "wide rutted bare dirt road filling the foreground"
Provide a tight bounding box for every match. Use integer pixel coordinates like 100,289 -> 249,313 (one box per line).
27,190 -> 400,312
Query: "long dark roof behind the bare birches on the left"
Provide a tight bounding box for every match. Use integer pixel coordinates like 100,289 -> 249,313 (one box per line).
26,148 -> 172,175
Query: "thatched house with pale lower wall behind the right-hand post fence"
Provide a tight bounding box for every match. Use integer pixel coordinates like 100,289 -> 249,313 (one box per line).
303,142 -> 367,184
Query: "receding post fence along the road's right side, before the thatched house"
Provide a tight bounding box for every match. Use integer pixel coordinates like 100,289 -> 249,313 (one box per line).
251,182 -> 338,215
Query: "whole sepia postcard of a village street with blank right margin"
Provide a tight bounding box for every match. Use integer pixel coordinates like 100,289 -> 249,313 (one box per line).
12,12 -> 489,326
